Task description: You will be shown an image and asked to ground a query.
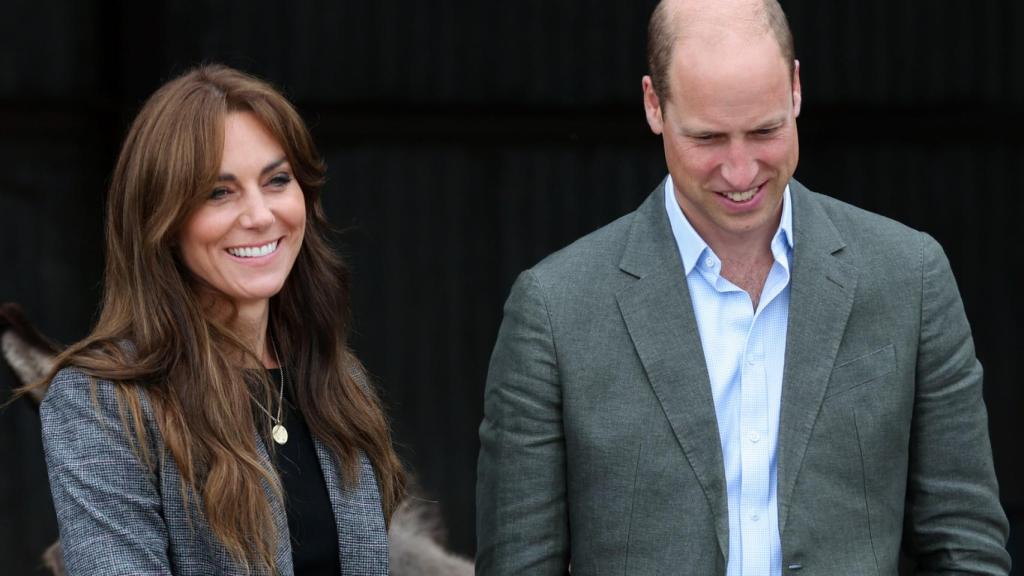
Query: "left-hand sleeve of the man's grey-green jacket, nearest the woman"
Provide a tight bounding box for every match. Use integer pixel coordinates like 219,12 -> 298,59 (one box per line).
476,271 -> 569,575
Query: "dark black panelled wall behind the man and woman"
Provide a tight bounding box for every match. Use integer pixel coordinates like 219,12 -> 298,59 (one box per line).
0,0 -> 1024,574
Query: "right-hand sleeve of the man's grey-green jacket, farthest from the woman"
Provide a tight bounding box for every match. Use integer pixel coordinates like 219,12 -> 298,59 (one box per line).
906,237 -> 1010,575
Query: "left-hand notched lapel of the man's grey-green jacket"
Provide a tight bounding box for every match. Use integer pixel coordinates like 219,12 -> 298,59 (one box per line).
616,184 -> 729,554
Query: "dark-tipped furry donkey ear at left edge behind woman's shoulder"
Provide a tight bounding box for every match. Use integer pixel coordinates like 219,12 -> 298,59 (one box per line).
0,302 -> 57,404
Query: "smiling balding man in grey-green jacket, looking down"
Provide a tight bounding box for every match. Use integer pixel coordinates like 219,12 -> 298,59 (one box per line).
477,0 -> 1010,576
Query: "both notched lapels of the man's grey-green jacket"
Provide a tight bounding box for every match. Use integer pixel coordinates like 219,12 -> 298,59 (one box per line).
616,180 -> 856,554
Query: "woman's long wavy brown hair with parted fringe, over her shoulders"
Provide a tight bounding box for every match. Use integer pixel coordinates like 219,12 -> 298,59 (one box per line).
48,65 -> 404,572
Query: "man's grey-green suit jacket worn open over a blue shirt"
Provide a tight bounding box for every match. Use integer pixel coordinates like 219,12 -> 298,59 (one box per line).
477,181 -> 1010,576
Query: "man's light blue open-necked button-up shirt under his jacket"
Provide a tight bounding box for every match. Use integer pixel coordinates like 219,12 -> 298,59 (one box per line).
665,177 -> 793,576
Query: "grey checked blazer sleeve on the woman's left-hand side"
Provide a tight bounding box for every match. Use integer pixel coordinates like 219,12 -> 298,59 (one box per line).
40,368 -> 171,576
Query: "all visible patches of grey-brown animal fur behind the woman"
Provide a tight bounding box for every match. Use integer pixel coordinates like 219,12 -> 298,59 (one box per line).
0,304 -> 473,576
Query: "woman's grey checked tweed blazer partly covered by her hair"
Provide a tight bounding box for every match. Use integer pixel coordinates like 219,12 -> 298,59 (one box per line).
40,369 -> 388,576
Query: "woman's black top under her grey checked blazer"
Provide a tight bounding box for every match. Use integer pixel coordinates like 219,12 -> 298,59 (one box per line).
264,370 -> 341,576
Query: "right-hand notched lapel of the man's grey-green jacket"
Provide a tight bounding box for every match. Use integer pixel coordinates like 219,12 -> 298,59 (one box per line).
777,180 -> 857,532
